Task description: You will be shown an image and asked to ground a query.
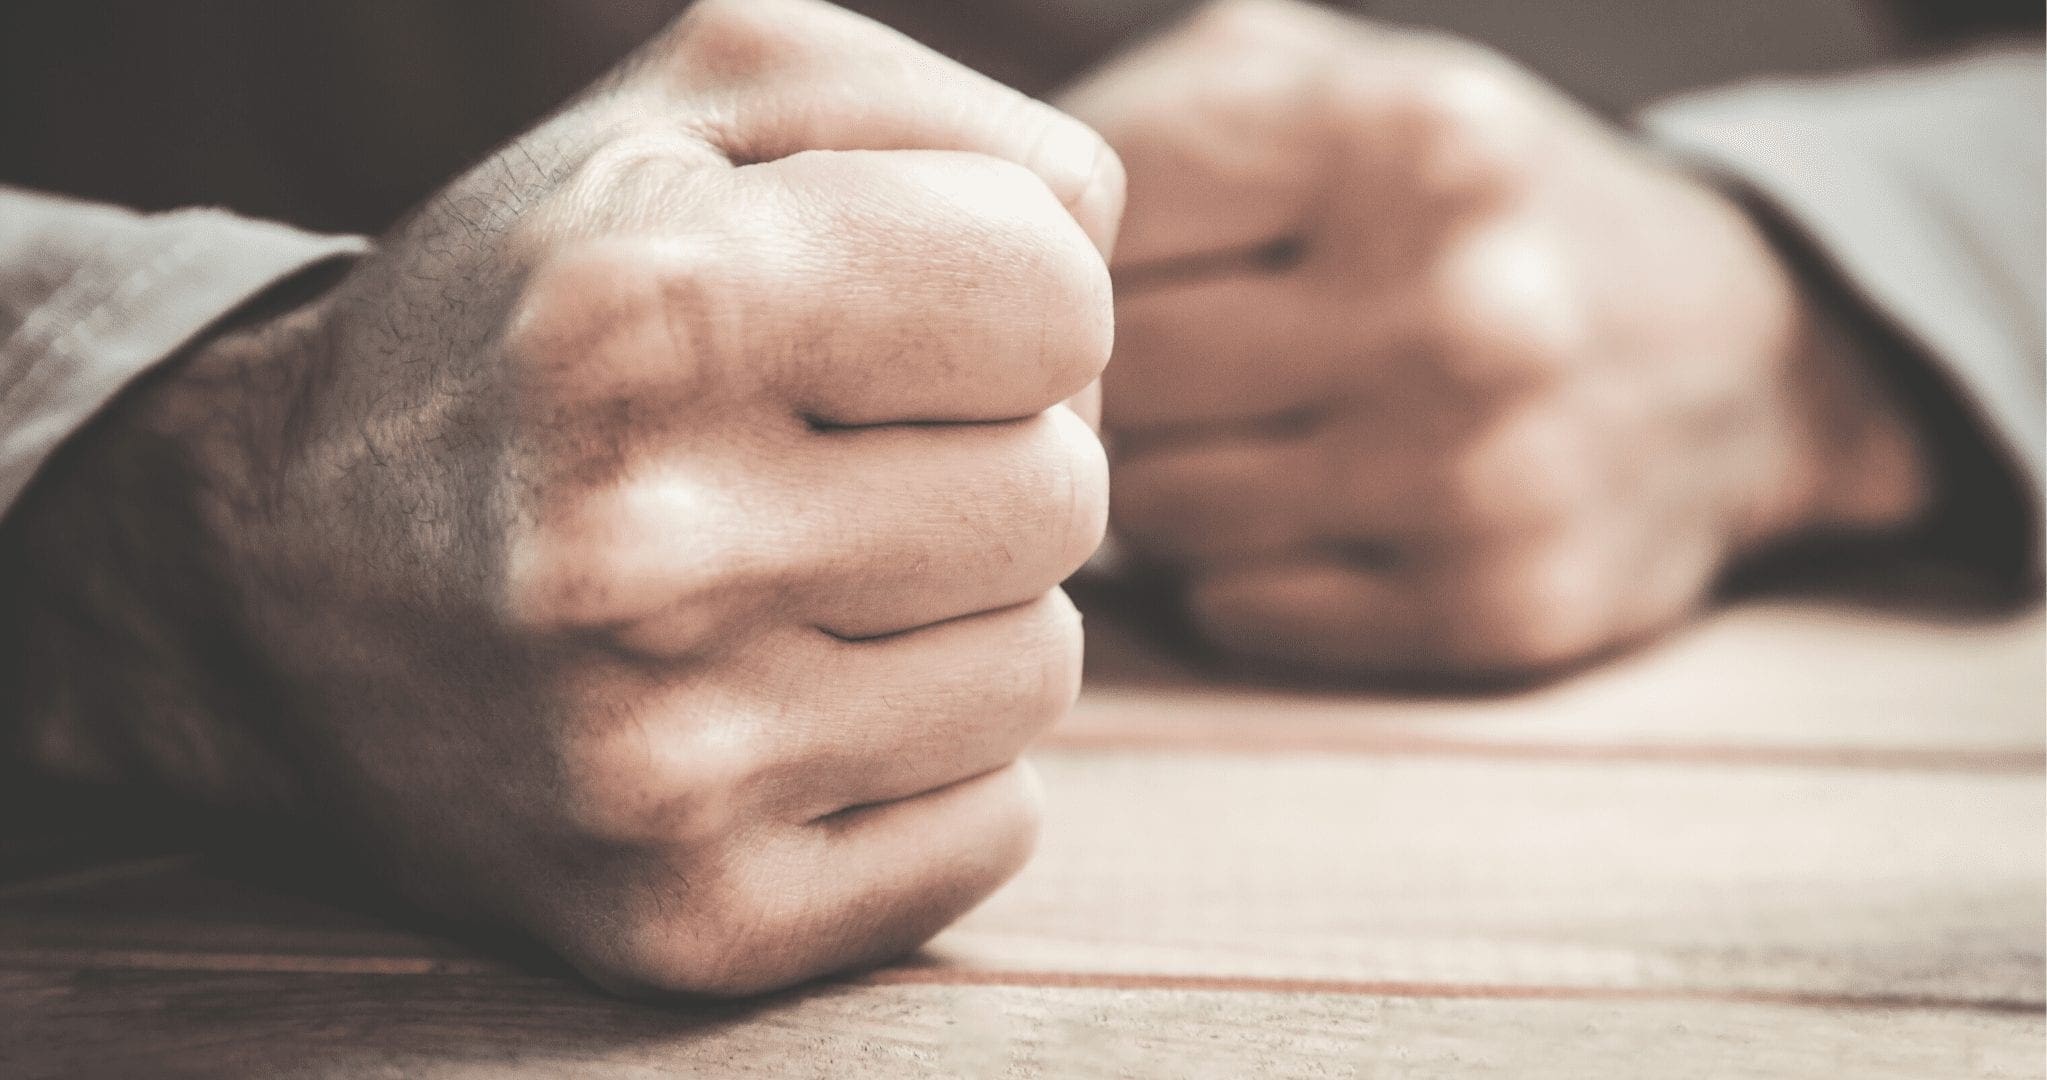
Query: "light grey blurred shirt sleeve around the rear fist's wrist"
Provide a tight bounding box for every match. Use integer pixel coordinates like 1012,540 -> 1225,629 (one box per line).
1640,45 -> 2047,577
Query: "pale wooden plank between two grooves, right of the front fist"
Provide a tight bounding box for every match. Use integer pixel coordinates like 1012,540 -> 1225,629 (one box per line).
935,753 -> 2047,1004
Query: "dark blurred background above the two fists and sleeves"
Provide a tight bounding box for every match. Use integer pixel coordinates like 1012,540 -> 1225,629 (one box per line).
0,0 -> 2041,233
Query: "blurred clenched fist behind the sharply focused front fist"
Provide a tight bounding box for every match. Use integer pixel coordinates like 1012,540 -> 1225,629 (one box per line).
1062,0 -> 1928,677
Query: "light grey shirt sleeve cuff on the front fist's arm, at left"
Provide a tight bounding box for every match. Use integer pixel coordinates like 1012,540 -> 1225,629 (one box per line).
0,186 -> 368,515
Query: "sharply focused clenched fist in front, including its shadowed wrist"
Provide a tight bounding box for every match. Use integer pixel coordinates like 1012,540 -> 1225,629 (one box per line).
0,0 -> 1122,994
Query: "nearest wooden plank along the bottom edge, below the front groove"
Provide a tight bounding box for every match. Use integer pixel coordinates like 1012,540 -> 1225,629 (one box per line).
0,972 -> 2043,1080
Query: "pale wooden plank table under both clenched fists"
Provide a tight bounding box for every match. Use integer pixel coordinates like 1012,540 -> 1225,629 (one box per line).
0,601 -> 2047,1080
